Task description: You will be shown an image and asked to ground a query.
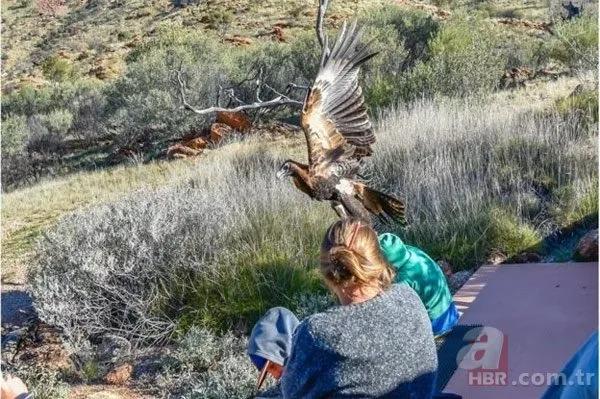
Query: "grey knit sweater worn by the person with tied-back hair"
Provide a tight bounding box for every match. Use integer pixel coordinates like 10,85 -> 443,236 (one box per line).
281,284 -> 437,398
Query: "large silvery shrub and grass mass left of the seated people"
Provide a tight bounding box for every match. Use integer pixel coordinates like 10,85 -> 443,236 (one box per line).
29,146 -> 335,347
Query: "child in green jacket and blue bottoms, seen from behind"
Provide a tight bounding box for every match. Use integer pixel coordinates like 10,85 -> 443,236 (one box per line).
379,233 -> 460,336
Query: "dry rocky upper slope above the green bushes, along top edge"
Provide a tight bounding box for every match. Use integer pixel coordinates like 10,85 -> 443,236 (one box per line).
2,0 -> 576,92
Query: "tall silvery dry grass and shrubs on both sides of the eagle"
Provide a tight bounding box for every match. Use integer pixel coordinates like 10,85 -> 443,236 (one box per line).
31,86 -> 598,350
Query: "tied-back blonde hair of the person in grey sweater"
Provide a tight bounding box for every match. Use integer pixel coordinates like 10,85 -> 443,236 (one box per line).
320,218 -> 394,289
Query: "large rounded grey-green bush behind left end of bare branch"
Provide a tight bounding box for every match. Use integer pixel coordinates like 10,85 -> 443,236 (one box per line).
106,25 -> 240,144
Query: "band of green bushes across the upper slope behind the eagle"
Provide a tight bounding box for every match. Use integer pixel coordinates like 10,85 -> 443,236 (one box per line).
7,2 -> 598,191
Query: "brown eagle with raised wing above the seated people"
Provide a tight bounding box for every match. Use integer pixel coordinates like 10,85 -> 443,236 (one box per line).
277,23 -> 406,225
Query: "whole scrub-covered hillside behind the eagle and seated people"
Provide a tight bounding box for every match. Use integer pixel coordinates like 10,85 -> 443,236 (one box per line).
1,0 -> 598,399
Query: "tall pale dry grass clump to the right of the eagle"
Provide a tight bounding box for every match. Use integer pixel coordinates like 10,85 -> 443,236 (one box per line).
373,91 -> 597,269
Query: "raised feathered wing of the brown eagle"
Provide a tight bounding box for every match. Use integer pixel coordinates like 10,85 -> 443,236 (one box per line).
301,23 -> 377,175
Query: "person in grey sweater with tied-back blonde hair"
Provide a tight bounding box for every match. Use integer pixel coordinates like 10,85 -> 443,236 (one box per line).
251,219 -> 437,398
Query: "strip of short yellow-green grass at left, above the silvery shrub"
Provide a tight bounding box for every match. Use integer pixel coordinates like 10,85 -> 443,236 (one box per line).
1,139 -> 298,284
